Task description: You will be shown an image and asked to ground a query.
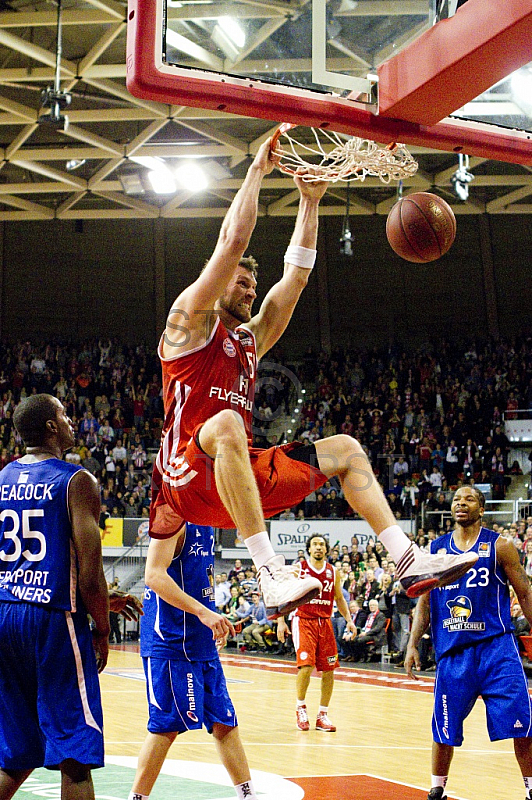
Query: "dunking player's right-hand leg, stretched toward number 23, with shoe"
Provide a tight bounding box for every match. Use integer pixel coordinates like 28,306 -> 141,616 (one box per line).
315,434 -> 478,597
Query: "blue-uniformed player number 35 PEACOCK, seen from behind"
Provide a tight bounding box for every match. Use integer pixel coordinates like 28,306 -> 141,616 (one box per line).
0,394 -> 109,800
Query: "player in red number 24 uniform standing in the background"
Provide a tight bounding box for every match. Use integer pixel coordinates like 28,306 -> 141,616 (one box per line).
277,533 -> 356,733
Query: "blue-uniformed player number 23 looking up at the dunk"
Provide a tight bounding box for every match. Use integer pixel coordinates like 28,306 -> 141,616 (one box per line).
405,486 -> 532,800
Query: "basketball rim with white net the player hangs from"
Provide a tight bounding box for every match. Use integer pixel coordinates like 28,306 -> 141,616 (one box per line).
271,122 -> 418,183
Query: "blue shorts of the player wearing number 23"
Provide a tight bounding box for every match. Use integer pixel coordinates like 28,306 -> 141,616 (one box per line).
432,634 -> 532,747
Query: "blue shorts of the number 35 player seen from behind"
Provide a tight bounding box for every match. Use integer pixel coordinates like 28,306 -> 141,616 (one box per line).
0,603 -> 104,770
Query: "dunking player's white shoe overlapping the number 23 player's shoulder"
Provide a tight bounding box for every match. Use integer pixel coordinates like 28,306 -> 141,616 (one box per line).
395,544 -> 478,597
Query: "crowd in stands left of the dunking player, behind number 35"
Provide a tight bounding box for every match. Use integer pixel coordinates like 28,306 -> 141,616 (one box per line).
0,339 -> 163,517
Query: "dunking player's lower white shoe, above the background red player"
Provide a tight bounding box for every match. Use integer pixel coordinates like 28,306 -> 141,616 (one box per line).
258,556 -> 322,619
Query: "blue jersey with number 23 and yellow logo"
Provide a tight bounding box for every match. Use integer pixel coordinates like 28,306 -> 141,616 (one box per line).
430,528 -> 514,659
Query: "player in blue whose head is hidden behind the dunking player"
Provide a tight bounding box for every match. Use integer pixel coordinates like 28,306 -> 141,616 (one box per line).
129,523 -> 256,800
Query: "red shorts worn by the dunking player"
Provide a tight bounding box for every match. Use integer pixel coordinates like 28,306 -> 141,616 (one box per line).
150,428 -> 328,538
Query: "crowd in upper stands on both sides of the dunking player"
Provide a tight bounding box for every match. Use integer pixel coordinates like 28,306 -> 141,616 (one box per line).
0,334 -> 532,519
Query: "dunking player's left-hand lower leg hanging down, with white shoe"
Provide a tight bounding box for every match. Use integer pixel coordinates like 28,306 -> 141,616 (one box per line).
198,410 -> 321,619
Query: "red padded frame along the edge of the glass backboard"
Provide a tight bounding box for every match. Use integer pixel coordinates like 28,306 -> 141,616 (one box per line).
126,0 -> 532,166
